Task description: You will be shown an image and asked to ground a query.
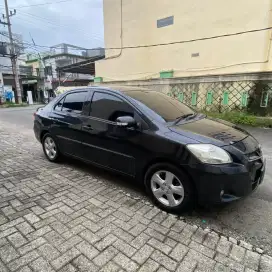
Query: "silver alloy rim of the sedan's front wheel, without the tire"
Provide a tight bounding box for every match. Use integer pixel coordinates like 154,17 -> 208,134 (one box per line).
151,170 -> 184,207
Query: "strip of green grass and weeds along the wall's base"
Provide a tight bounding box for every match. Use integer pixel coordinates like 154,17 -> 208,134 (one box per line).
205,112 -> 272,127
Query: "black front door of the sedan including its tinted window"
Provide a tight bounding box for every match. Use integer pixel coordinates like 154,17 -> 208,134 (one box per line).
79,91 -> 146,176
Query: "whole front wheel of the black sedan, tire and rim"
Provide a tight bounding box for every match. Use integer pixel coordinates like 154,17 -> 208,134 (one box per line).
144,163 -> 195,213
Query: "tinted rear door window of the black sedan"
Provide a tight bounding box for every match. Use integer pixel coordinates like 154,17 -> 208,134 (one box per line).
62,92 -> 86,113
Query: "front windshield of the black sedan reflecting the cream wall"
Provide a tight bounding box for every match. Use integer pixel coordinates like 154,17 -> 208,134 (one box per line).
124,91 -> 195,122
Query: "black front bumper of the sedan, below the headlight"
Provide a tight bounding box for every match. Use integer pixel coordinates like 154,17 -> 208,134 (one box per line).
186,157 -> 266,204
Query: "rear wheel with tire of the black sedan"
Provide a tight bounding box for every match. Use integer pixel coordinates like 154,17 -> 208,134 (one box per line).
42,133 -> 60,162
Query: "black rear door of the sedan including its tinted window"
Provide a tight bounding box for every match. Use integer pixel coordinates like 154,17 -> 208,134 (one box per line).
50,90 -> 88,157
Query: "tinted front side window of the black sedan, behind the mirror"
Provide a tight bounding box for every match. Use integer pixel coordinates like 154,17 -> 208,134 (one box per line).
90,92 -> 134,122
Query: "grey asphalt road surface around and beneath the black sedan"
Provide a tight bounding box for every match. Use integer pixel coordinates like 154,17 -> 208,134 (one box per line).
0,106 -> 272,254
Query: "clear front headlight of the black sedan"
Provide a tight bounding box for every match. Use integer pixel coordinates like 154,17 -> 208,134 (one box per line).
187,144 -> 232,164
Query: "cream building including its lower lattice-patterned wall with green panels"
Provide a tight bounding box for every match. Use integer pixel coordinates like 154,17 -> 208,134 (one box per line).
96,0 -> 272,114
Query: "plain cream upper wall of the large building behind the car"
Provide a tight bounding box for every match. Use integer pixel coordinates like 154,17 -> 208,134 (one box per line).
96,0 -> 272,81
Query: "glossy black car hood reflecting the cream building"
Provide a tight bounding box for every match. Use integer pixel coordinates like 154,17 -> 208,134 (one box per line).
169,117 -> 249,146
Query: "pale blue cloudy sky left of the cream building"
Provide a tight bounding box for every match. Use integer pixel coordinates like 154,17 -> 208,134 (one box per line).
0,0 -> 104,51
